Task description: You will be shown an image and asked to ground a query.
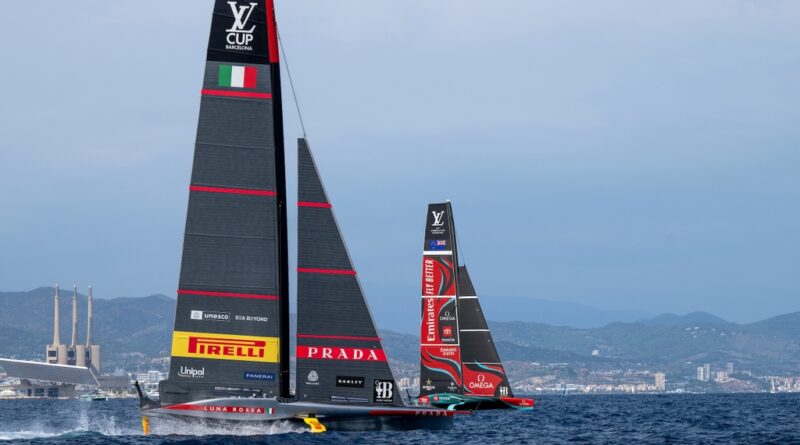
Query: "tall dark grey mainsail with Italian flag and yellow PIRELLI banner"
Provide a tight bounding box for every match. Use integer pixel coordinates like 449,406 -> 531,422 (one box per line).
160,0 -> 289,403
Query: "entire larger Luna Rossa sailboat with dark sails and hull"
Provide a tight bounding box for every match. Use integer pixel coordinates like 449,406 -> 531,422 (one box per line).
137,0 -> 460,432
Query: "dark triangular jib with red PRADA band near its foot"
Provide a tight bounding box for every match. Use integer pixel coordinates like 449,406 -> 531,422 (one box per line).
296,139 -> 402,405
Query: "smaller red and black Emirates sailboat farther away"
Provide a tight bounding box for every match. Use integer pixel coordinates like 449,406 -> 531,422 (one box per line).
418,201 -> 534,410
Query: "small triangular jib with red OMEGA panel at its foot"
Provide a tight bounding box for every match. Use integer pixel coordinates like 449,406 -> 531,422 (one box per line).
458,266 -> 513,397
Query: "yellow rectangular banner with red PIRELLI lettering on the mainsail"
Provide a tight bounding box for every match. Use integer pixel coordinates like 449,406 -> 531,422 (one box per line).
172,331 -> 278,363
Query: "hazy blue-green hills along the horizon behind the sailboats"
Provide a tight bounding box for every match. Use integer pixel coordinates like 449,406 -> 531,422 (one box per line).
0,288 -> 800,373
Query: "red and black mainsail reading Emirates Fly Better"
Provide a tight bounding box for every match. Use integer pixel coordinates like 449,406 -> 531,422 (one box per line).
420,202 -> 462,395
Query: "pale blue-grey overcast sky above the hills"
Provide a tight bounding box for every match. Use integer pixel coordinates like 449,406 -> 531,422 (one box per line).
0,0 -> 800,328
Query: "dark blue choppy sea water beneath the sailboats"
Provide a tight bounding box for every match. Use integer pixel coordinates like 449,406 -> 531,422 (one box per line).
0,394 -> 800,445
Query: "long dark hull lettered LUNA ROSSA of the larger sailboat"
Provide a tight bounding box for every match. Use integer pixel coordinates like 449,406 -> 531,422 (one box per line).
141,398 -> 468,431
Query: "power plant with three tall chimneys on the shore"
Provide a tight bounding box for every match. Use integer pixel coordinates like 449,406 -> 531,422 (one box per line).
46,284 -> 100,376
